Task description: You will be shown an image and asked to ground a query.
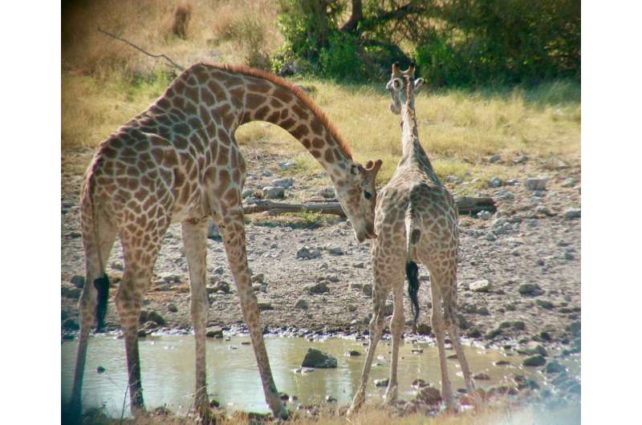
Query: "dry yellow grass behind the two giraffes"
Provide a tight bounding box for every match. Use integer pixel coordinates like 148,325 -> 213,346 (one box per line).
62,0 -> 580,189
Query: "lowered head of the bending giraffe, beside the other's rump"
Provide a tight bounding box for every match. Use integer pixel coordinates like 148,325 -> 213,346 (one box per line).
335,159 -> 382,242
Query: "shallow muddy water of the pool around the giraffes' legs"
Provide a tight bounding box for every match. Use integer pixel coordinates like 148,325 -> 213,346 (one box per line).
62,336 -> 564,417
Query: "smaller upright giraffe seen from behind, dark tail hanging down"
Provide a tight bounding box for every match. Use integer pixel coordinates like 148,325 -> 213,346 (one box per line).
350,64 -> 473,413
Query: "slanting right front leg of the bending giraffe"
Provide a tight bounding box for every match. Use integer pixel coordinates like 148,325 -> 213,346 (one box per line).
219,206 -> 288,419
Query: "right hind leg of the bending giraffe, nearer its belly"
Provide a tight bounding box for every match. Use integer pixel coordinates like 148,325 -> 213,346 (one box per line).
116,219 -> 169,416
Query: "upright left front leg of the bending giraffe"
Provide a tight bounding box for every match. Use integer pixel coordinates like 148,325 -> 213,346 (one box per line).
182,219 -> 210,421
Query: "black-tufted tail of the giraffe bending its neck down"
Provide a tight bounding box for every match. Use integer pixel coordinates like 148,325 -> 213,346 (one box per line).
83,166 -> 110,332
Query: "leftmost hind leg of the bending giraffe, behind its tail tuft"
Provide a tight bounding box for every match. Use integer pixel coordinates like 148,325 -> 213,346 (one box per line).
67,205 -> 116,421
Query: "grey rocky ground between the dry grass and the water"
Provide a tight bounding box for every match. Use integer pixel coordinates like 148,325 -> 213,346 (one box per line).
61,147 -> 581,360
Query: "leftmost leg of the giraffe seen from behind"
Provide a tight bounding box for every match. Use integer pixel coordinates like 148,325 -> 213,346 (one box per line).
348,278 -> 390,416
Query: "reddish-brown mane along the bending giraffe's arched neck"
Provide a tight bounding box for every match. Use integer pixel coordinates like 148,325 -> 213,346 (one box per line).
205,63 -> 352,159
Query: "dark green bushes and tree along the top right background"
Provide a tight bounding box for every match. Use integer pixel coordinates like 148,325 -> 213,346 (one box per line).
278,0 -> 581,86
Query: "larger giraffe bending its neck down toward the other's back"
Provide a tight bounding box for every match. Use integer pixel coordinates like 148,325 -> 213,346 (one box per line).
71,63 -> 381,418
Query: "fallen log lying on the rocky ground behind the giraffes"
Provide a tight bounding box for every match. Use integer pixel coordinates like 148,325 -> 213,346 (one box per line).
243,196 -> 497,217
